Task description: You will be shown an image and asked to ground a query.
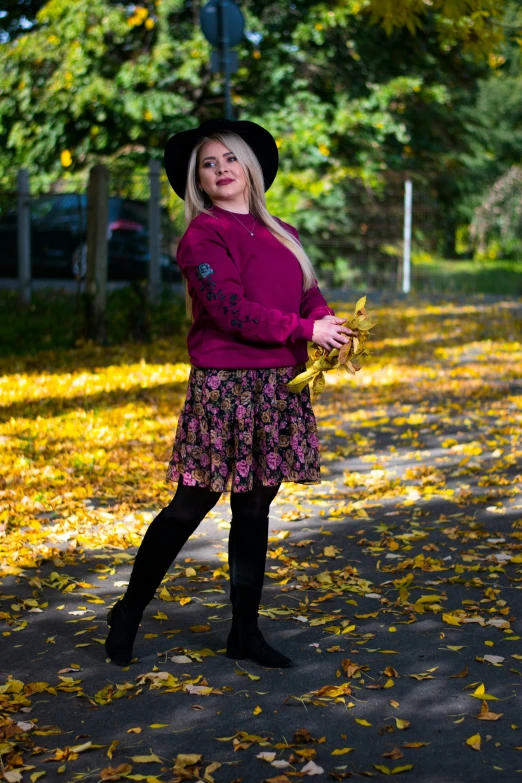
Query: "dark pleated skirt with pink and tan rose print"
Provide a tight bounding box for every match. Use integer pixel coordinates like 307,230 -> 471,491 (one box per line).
166,364 -> 321,492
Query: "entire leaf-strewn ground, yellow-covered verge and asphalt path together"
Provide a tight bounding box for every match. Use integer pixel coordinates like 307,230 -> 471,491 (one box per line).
0,298 -> 522,783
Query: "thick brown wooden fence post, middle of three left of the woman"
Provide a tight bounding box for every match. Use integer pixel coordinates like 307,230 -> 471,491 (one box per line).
85,164 -> 109,343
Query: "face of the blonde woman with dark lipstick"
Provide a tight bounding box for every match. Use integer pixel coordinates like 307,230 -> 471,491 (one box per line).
197,140 -> 247,203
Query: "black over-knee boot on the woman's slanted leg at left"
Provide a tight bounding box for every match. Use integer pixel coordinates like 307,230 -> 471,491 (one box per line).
105,481 -> 221,666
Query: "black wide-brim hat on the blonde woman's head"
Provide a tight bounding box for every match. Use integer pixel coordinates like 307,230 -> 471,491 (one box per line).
163,117 -> 279,199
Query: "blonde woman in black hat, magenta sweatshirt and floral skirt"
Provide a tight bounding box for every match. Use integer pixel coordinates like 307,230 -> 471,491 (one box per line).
105,119 -> 351,667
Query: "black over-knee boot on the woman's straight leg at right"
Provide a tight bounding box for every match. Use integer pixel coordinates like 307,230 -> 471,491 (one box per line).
226,487 -> 292,668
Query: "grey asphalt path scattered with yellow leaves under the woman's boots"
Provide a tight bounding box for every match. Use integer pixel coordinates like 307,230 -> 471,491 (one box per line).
0,298 -> 522,783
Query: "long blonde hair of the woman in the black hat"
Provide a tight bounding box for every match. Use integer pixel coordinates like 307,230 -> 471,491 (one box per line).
183,131 -> 315,321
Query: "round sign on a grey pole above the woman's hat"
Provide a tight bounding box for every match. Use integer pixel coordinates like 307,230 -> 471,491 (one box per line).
200,0 -> 245,120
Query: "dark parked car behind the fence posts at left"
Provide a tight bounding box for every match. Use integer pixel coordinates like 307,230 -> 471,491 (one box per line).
0,193 -> 182,282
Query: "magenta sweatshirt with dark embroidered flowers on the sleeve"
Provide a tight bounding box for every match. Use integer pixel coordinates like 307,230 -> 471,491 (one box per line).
176,206 -> 335,370
